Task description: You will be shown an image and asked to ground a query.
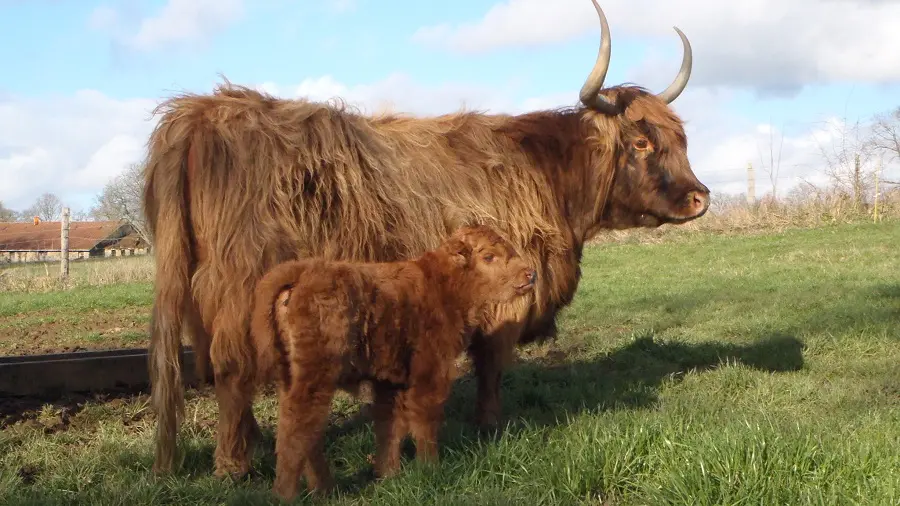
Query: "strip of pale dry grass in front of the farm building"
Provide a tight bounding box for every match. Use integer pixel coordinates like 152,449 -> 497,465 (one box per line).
0,255 -> 155,293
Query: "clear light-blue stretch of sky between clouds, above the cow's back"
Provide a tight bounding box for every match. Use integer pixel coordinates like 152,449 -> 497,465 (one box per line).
0,0 -> 664,98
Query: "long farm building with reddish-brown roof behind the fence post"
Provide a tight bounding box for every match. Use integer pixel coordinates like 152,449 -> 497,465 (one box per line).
0,220 -> 148,263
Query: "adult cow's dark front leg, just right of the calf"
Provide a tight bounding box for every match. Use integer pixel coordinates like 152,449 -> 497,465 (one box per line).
468,323 -> 522,430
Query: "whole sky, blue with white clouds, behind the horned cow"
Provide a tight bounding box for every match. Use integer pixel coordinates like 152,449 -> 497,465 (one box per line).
0,0 -> 900,213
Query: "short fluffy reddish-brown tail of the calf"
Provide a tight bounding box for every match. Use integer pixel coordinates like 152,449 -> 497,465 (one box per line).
250,260 -> 309,385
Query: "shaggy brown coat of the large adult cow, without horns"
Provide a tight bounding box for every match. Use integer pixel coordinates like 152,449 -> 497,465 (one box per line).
144,57 -> 708,475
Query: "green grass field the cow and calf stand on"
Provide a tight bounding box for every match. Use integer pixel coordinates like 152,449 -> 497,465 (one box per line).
0,222 -> 900,506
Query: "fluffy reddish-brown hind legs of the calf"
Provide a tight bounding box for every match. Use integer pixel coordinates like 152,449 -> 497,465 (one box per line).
272,378 -> 335,501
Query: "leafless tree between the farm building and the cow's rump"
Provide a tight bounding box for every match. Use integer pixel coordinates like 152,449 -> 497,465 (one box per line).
91,163 -> 150,244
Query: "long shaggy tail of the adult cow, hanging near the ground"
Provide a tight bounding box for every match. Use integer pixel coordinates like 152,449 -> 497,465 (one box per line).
143,106 -> 206,474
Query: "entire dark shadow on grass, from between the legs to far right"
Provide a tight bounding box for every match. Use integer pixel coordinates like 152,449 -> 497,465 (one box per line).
165,335 -> 803,496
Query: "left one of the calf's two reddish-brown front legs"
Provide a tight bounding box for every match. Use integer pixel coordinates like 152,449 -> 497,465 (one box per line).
372,385 -> 408,478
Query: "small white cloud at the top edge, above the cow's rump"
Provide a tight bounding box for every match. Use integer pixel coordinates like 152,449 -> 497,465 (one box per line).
88,0 -> 244,51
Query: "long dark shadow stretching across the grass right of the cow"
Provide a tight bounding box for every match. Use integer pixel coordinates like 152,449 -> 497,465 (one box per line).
458,334 -> 804,426
